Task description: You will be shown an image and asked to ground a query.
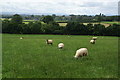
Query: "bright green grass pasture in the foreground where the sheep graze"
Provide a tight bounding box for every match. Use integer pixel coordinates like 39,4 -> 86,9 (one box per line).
2,34 -> 118,78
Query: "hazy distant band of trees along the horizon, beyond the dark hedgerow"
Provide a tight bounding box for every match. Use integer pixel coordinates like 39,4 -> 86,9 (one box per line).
2,13 -> 120,22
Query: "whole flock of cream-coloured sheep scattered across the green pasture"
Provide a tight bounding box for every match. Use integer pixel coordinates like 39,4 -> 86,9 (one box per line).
20,37 -> 97,59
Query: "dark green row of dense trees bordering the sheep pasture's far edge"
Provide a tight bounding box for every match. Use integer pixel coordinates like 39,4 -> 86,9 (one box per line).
2,14 -> 120,36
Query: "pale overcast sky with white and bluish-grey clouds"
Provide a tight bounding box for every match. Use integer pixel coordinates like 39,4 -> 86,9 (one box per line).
0,0 -> 119,15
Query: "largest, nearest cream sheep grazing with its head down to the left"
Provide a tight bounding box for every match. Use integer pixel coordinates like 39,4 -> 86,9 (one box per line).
74,48 -> 88,58
